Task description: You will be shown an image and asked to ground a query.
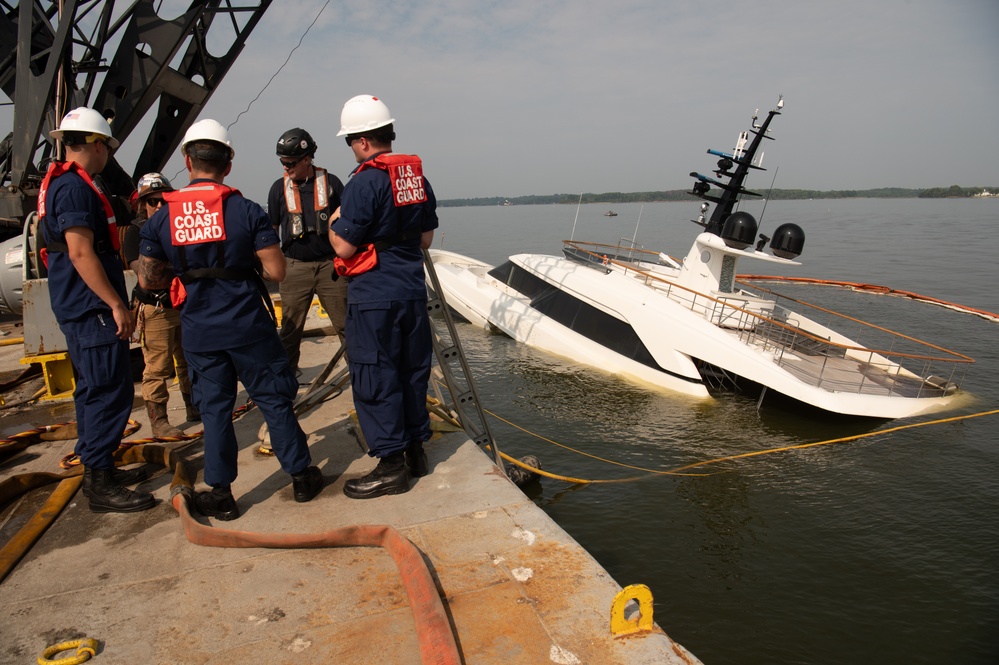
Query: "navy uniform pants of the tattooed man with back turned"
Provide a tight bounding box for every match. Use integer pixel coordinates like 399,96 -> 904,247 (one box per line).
184,330 -> 312,487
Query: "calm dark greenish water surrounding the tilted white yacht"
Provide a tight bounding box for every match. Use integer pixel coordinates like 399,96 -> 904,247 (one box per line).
434,199 -> 999,665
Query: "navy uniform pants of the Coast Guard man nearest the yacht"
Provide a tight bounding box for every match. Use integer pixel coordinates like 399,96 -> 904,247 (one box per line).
347,300 -> 433,458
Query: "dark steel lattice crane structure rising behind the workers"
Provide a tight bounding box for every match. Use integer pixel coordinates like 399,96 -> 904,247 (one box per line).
0,0 -> 271,228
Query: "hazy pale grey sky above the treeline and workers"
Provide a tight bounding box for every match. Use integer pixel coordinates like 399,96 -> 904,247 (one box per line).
8,0 -> 999,200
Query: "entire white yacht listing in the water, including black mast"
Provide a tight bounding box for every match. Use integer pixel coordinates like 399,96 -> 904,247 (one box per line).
430,99 -> 974,419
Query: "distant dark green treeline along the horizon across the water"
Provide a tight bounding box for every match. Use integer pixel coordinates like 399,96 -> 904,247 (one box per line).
437,185 -> 999,207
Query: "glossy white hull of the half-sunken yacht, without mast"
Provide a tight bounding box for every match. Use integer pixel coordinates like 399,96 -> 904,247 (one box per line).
430,250 -> 959,418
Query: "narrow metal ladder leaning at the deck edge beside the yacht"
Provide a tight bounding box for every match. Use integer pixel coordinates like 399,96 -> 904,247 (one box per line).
423,249 -> 505,473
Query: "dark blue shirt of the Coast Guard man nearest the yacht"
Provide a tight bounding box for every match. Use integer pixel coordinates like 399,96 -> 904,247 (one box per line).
333,156 -> 439,304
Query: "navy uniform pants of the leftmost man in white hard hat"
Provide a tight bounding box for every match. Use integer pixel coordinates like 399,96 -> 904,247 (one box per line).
59,310 -> 135,469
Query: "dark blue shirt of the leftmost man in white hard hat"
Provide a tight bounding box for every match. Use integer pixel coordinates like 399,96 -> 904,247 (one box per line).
42,172 -> 128,323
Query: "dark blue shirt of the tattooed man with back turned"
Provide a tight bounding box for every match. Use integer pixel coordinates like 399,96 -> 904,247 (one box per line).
139,180 -> 278,352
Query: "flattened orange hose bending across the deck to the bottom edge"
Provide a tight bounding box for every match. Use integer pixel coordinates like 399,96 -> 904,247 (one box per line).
172,492 -> 461,665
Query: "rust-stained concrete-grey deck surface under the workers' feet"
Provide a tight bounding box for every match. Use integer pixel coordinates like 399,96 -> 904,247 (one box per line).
0,312 -> 698,665
